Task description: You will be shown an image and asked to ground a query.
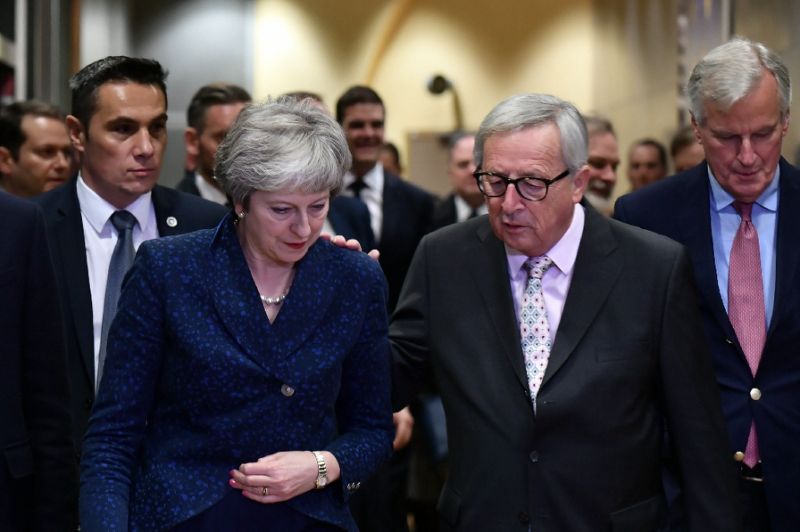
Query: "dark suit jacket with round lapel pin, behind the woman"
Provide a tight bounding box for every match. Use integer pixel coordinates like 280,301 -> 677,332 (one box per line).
37,179 -> 227,462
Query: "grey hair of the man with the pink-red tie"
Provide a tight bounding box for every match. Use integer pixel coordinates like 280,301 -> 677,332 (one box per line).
686,37 -> 792,125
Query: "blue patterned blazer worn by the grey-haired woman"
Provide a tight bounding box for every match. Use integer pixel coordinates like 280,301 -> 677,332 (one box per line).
81,215 -> 393,532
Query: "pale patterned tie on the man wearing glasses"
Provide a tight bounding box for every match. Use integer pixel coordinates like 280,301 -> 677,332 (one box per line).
519,256 -> 553,410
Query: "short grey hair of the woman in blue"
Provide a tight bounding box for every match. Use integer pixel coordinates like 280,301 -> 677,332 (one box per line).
214,98 -> 351,204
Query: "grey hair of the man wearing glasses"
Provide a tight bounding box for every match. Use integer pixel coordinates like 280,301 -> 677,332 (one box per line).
475,94 -> 588,174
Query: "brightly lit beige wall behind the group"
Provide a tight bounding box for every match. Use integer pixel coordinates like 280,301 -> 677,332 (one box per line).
253,0 -> 677,197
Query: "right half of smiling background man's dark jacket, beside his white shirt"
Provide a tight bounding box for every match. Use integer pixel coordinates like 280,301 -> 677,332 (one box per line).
378,171 -> 435,311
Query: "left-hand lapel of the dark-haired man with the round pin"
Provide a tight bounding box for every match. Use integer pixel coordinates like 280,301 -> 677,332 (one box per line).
53,180 -> 94,383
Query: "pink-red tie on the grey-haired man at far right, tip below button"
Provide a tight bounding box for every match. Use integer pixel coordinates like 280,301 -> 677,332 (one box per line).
728,201 -> 767,467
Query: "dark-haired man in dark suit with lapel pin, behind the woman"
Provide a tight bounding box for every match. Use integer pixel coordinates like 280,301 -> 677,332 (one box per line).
38,56 -> 227,512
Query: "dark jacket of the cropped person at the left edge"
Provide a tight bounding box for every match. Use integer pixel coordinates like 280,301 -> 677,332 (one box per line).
0,192 -> 78,530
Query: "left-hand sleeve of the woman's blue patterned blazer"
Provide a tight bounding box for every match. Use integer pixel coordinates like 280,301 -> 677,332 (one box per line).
80,242 -> 165,532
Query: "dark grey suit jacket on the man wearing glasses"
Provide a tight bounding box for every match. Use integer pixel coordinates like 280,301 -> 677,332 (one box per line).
390,207 -> 739,532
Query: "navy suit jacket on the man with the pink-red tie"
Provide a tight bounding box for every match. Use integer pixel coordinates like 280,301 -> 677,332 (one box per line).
614,159 -> 800,531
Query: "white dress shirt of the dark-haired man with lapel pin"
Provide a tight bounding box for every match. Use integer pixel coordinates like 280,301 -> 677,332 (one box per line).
77,176 -> 158,377
